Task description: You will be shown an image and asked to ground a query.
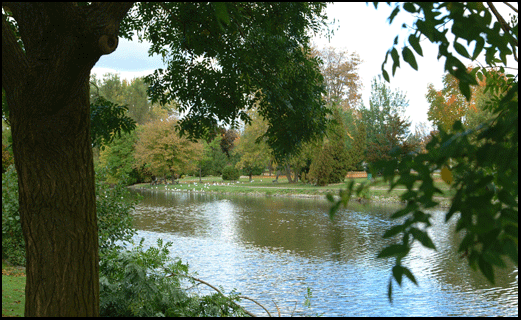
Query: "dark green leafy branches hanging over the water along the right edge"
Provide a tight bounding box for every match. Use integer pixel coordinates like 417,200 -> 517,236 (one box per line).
328,2 -> 518,301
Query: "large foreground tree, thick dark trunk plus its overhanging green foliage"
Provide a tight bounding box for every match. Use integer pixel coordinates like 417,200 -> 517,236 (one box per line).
2,2 -> 326,316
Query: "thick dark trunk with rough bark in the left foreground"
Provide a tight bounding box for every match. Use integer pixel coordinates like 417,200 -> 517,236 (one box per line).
2,2 -> 132,317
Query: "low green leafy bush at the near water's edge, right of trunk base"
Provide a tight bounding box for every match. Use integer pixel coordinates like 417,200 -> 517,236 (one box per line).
100,239 -> 249,317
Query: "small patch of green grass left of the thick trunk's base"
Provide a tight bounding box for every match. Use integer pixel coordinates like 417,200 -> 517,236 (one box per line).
2,261 -> 25,317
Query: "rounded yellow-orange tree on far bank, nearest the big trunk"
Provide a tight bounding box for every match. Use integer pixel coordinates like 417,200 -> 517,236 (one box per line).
134,119 -> 203,177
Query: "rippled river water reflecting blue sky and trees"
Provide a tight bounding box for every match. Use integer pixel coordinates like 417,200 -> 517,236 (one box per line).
126,191 -> 518,316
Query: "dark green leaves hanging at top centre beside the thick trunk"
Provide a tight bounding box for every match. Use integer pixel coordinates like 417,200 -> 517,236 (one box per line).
121,2 -> 327,158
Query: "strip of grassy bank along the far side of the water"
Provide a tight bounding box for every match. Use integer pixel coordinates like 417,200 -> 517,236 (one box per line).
128,176 -> 452,206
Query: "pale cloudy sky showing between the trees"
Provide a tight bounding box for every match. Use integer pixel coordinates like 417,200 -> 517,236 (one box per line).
92,2 -> 517,130
